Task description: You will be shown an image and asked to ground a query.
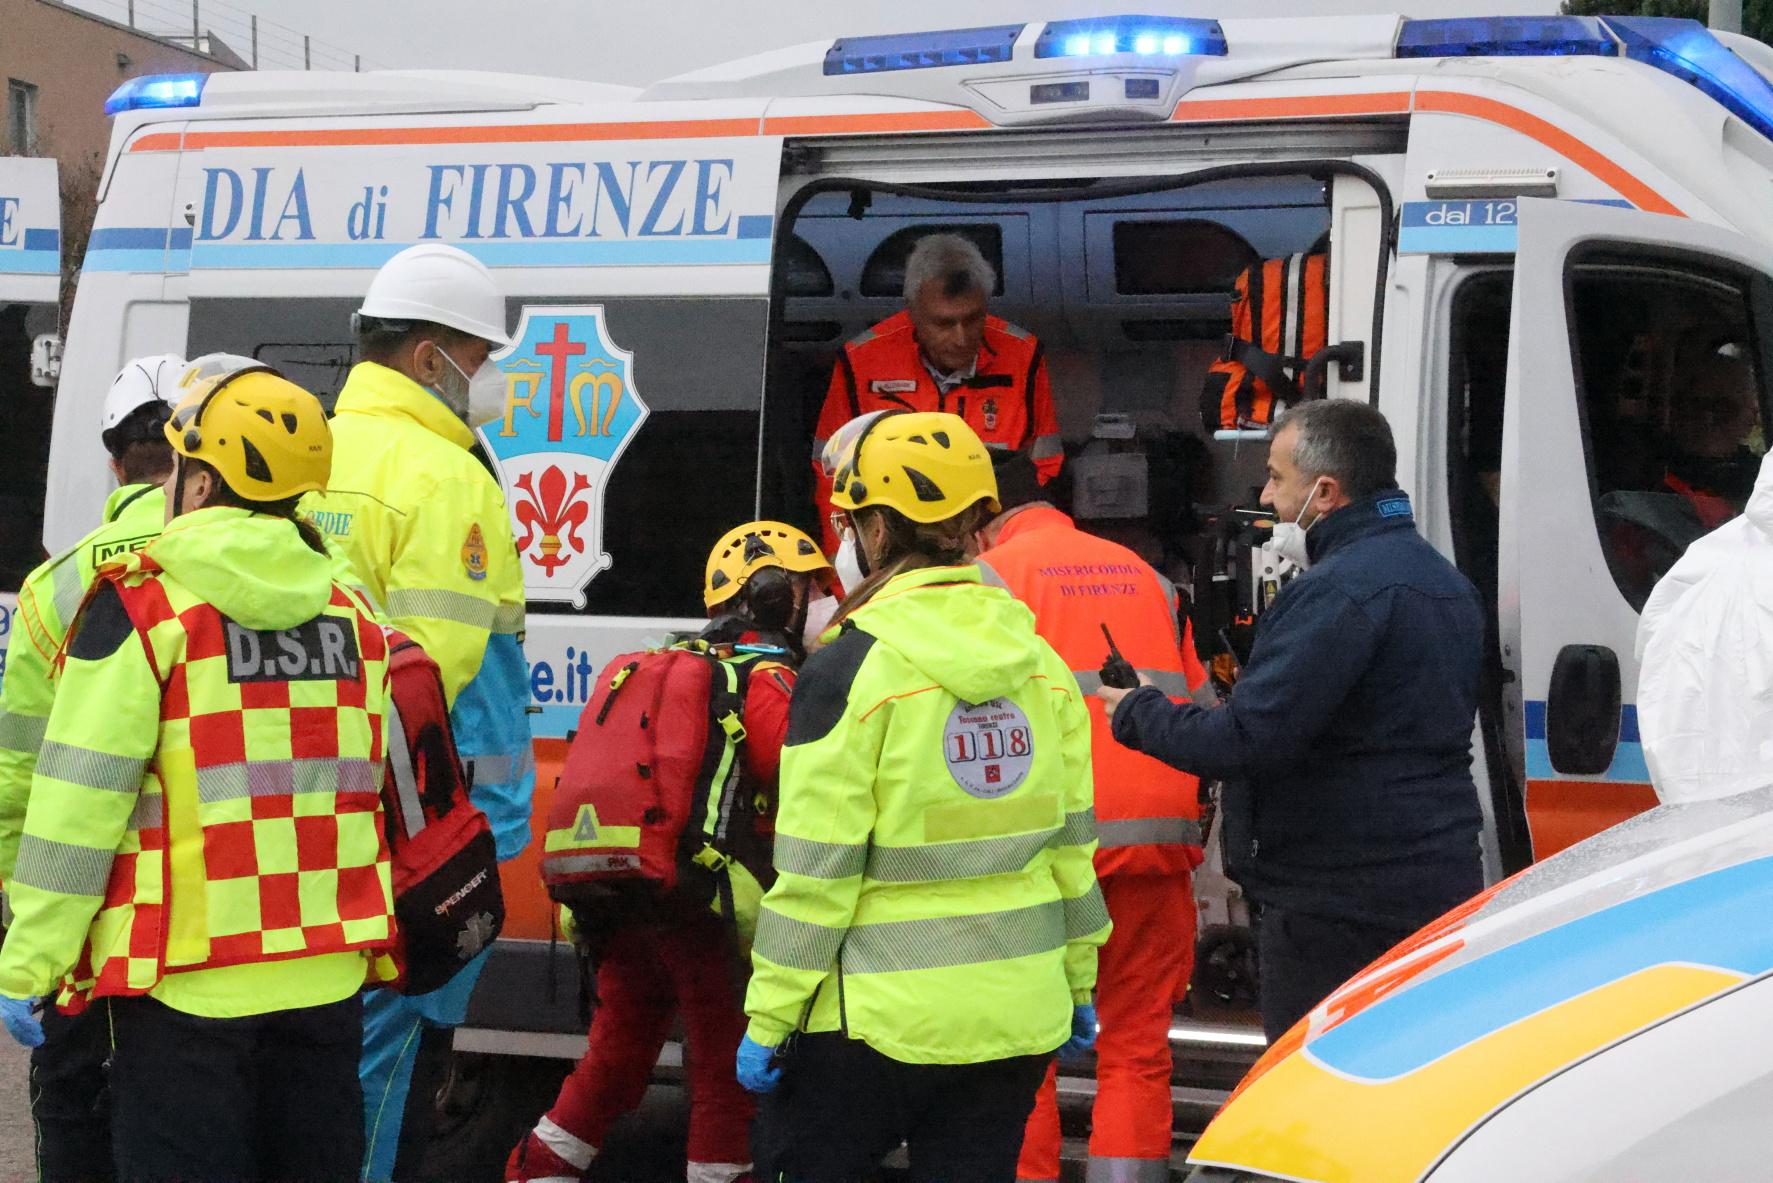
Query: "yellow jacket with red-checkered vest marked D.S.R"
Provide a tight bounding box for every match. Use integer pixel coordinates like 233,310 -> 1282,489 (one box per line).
0,507 -> 392,1018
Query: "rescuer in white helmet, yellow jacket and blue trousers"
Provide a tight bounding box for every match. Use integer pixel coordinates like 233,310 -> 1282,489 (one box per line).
301,243 -> 535,1183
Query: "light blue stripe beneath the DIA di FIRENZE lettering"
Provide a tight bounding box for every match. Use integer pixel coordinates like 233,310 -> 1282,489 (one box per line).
191,238 -> 769,270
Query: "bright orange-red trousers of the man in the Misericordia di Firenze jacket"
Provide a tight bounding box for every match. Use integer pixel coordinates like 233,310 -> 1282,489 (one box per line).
1016,874 -> 1195,1183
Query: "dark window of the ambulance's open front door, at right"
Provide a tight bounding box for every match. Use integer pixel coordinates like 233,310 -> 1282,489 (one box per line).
1567,252 -> 1773,608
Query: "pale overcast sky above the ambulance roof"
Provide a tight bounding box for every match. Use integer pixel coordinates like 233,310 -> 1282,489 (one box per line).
69,0 -> 1557,85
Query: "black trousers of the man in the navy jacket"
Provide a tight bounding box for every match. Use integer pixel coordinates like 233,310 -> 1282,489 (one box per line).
1255,905 -> 1415,1043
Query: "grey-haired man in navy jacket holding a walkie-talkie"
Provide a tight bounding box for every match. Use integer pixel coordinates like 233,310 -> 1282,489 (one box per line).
1097,399 -> 1484,1041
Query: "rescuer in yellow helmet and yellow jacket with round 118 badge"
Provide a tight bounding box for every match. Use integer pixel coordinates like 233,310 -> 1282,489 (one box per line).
738,411 -> 1108,1183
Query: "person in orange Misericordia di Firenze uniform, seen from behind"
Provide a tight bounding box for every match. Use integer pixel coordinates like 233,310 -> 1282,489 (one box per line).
979,458 -> 1211,1183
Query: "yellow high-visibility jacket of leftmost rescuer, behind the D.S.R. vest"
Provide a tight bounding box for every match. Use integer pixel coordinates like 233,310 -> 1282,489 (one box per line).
0,484 -> 167,883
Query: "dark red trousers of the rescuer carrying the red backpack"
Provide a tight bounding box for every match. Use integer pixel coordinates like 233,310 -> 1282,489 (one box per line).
548,915 -> 755,1163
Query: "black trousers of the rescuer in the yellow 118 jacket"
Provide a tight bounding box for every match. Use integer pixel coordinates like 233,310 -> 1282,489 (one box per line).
752,1032 -> 1053,1183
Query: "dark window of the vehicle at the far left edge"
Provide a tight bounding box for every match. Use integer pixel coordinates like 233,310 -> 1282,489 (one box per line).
0,303 -> 55,592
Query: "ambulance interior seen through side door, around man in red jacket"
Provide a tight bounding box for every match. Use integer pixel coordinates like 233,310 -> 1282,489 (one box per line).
762,172 -> 1333,653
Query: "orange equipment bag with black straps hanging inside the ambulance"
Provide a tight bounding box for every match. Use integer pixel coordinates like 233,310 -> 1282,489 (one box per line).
1200,252 -> 1330,431
